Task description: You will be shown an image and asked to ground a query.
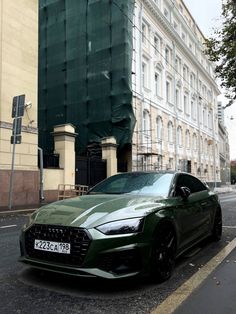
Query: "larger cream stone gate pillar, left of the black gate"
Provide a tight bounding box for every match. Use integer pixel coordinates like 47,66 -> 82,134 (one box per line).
53,124 -> 77,184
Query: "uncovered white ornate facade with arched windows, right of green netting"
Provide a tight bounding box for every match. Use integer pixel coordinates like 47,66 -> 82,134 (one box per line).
132,0 -> 220,184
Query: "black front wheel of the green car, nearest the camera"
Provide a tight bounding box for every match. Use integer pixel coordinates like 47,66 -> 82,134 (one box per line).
150,224 -> 176,282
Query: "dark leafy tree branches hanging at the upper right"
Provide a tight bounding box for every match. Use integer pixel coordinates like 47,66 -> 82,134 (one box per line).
205,0 -> 236,107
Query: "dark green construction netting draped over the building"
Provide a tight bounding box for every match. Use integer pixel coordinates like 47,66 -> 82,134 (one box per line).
38,0 -> 135,154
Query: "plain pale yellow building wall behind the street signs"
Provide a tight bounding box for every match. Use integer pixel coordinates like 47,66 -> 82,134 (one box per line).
0,0 -> 39,207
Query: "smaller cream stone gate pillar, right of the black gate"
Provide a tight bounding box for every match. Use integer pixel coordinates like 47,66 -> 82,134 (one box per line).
101,136 -> 117,177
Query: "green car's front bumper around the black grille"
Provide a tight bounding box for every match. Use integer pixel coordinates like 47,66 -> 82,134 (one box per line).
19,224 -> 150,279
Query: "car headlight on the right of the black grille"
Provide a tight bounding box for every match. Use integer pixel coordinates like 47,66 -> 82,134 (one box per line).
96,218 -> 144,235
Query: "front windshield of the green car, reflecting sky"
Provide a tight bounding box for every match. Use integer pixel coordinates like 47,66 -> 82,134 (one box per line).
89,172 -> 173,197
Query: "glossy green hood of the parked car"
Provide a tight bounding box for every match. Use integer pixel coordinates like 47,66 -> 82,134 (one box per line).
31,194 -> 167,229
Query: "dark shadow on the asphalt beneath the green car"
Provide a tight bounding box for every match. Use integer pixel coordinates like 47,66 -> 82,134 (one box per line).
18,239 -> 224,299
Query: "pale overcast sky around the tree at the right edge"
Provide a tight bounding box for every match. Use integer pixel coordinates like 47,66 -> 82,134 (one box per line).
184,0 -> 236,159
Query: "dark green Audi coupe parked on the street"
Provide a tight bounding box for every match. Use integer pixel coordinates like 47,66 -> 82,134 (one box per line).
19,171 -> 222,281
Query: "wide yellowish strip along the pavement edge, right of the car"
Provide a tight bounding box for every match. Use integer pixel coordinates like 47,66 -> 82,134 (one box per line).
151,238 -> 236,314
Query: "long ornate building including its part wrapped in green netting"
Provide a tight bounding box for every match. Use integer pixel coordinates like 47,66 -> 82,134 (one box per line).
39,0 -> 223,189
